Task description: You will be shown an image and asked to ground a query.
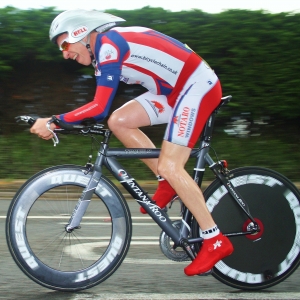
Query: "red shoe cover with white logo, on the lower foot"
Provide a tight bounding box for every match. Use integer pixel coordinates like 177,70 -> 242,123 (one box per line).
184,233 -> 233,276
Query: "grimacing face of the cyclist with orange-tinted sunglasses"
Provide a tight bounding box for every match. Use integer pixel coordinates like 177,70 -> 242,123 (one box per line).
57,33 -> 91,66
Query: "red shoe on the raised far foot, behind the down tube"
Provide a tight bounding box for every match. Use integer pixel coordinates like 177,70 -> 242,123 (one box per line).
140,180 -> 176,214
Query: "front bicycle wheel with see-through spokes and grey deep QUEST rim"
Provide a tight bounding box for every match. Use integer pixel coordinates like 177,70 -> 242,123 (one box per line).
6,165 -> 132,291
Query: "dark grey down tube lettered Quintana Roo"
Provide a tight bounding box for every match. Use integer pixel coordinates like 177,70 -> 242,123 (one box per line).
104,157 -> 181,245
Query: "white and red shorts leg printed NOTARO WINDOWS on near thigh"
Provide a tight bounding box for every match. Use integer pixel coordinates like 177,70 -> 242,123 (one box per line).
164,62 -> 222,148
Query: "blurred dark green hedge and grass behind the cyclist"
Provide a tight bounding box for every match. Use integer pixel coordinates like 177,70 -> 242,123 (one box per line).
0,7 -> 300,182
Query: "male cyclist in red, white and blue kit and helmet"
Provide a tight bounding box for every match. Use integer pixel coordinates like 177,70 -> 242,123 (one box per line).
31,10 -> 233,276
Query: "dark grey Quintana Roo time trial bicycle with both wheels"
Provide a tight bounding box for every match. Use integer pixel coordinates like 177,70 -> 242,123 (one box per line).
6,96 -> 300,291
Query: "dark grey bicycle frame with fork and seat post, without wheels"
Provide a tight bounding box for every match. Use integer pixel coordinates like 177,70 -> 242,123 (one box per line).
66,97 -> 259,259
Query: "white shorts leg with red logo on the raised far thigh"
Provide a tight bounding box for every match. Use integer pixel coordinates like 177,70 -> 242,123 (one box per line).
135,92 -> 173,125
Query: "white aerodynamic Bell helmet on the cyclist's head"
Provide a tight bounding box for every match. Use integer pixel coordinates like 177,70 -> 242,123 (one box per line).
49,9 -> 125,44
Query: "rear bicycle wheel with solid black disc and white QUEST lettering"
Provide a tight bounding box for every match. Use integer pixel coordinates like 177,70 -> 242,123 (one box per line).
192,167 -> 300,290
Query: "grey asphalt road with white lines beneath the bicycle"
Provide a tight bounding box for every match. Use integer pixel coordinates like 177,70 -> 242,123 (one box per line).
0,200 -> 300,300
